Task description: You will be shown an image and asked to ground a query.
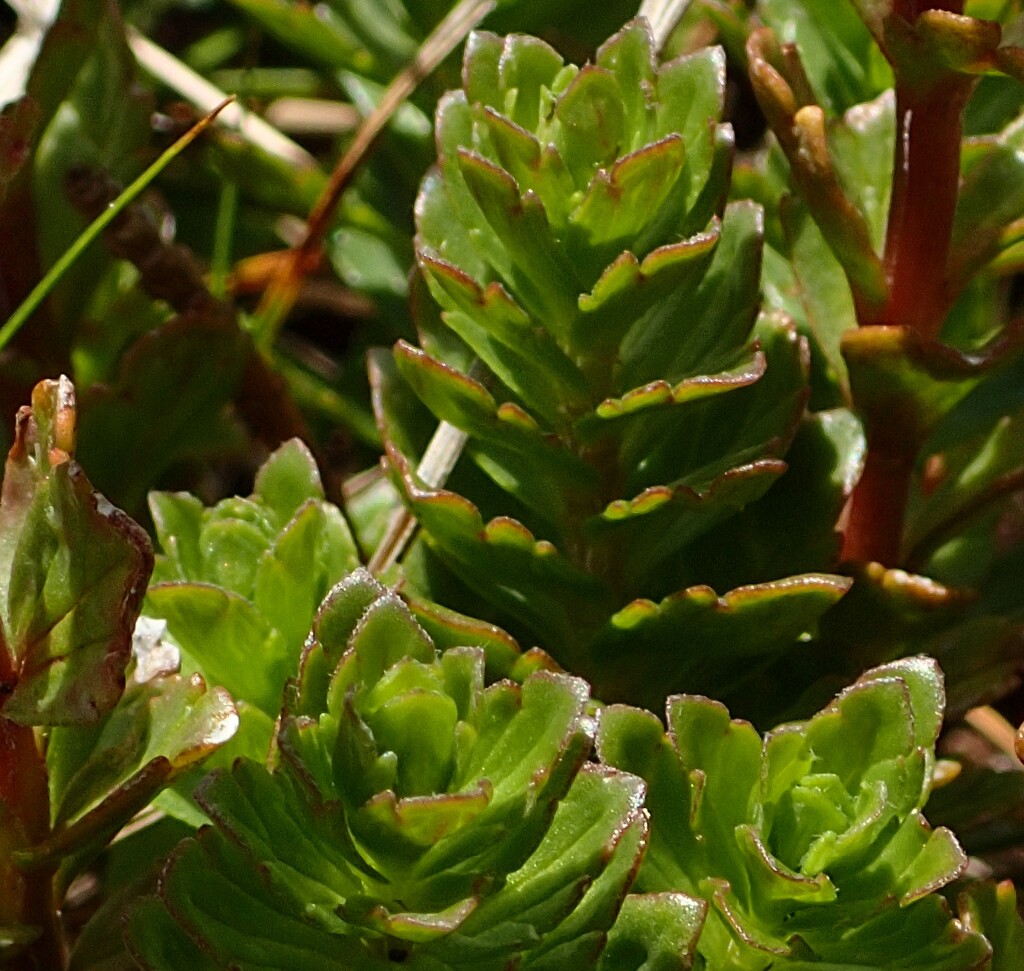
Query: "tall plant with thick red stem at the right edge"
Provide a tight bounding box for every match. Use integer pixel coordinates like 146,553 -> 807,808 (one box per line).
733,0 -> 1024,714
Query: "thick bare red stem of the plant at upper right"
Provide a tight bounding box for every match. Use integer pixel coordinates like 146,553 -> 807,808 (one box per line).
842,30 -> 973,565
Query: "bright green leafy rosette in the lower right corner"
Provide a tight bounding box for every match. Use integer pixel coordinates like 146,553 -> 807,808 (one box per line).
598,658 -> 995,971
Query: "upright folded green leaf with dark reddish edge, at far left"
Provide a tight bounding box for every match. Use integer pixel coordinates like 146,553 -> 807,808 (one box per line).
0,377 -> 153,725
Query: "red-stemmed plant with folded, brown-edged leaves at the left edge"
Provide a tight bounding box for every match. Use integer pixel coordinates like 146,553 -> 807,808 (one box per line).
0,378 -> 238,968
